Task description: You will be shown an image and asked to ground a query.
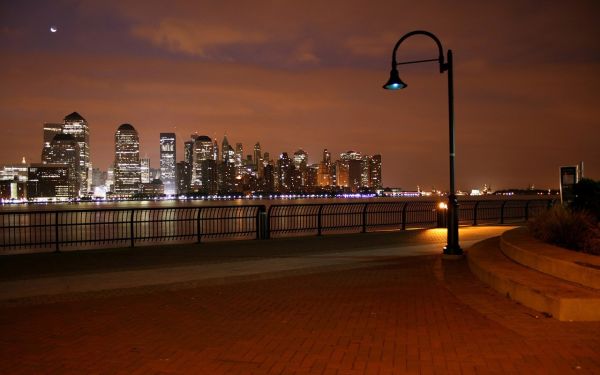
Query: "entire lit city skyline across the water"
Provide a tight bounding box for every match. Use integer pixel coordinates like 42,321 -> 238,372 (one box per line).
0,112 -> 383,200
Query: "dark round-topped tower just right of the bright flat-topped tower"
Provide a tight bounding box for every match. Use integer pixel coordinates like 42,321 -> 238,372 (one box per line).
192,135 -> 217,194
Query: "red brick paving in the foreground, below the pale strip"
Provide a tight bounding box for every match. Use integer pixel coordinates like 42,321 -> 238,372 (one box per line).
0,228 -> 600,375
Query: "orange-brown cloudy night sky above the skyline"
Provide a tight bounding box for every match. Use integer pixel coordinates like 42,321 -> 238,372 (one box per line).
0,0 -> 600,190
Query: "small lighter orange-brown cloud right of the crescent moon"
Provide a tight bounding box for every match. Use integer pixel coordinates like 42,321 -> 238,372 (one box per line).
131,18 -> 269,57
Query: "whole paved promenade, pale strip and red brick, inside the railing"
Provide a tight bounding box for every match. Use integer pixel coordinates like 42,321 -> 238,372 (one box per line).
0,226 -> 600,374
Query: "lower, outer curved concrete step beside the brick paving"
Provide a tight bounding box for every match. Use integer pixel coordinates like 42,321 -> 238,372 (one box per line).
467,237 -> 600,321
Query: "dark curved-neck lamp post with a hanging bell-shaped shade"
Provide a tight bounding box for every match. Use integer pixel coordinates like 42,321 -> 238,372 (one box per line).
383,30 -> 463,255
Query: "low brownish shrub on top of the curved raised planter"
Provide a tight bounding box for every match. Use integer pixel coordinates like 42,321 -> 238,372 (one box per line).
529,205 -> 600,255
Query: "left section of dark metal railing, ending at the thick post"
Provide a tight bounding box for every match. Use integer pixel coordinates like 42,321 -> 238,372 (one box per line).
0,205 -> 265,251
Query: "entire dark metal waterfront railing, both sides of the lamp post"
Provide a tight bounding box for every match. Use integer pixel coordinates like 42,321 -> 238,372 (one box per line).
0,199 -> 553,251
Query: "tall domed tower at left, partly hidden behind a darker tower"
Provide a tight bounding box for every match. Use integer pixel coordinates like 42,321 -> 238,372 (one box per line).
62,112 -> 92,195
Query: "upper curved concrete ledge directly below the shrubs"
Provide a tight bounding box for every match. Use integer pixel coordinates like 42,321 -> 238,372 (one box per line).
500,228 -> 600,290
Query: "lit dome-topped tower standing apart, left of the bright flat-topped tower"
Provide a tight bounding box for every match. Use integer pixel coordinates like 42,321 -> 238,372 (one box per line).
114,124 -> 142,197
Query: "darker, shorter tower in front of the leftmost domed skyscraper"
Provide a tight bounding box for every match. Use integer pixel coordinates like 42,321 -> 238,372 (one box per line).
42,133 -> 81,198
